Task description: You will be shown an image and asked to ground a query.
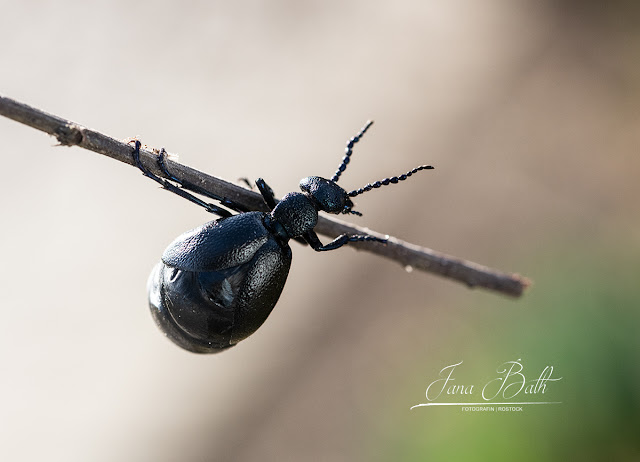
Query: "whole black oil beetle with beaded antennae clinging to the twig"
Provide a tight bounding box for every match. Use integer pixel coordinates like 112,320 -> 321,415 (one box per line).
133,121 -> 433,353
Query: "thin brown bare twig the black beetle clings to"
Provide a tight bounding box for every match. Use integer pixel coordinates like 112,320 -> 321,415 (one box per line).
0,96 -> 530,297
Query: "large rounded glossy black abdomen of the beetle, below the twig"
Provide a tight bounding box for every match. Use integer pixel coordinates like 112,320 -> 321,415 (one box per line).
148,214 -> 291,353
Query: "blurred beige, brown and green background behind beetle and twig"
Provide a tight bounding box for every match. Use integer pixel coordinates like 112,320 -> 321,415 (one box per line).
0,0 -> 640,461
